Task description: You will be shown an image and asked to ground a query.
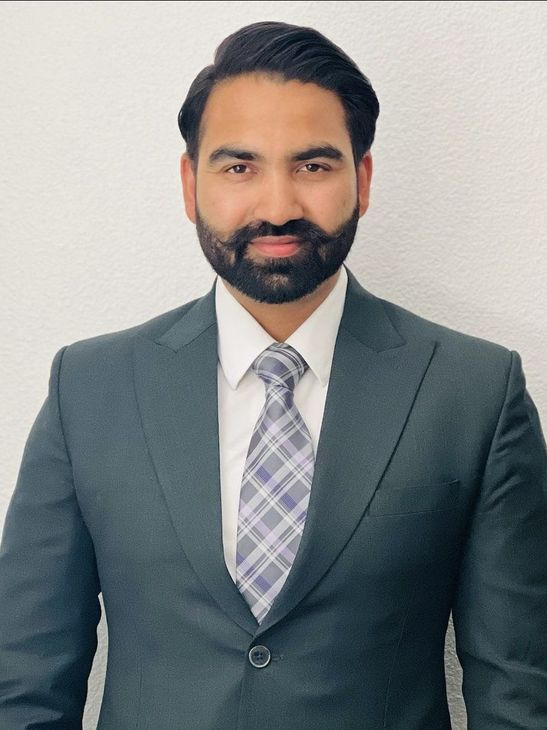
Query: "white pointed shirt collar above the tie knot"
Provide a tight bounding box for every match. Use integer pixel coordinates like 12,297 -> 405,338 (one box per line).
215,266 -> 348,390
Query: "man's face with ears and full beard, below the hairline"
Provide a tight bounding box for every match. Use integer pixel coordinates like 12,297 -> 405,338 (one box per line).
181,74 -> 372,304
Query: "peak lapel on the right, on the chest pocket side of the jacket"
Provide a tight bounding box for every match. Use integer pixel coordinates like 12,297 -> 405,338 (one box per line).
255,270 -> 435,638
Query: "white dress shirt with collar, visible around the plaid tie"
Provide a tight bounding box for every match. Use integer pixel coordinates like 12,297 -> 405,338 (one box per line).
215,266 -> 348,583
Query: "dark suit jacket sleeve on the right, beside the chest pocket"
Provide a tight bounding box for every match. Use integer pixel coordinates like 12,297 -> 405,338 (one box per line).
453,351 -> 547,730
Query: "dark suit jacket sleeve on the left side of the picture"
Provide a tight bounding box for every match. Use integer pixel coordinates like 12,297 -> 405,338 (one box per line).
0,347 -> 101,730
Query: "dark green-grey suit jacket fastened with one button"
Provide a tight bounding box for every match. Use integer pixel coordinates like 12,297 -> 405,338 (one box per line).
0,270 -> 547,730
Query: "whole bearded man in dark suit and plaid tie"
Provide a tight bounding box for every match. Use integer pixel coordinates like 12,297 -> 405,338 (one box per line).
0,22 -> 547,730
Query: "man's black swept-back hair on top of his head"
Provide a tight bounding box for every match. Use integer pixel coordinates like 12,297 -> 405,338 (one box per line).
178,21 -> 380,166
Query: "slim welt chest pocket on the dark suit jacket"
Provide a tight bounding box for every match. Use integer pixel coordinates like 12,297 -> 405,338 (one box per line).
368,479 -> 460,517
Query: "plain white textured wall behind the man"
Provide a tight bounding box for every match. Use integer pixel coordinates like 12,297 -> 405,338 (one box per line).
0,0 -> 547,730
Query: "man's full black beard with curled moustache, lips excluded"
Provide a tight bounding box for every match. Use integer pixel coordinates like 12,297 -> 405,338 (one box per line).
196,202 -> 359,304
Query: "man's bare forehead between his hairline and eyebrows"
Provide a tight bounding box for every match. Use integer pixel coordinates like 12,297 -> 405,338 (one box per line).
200,74 -> 351,157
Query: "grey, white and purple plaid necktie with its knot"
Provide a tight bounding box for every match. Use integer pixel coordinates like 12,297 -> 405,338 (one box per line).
236,342 -> 314,623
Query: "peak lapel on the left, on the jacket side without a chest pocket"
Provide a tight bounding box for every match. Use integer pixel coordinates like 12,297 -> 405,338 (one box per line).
134,278 -> 257,634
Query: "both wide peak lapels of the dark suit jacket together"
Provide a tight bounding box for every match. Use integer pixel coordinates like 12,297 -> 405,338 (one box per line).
134,270 -> 435,636
